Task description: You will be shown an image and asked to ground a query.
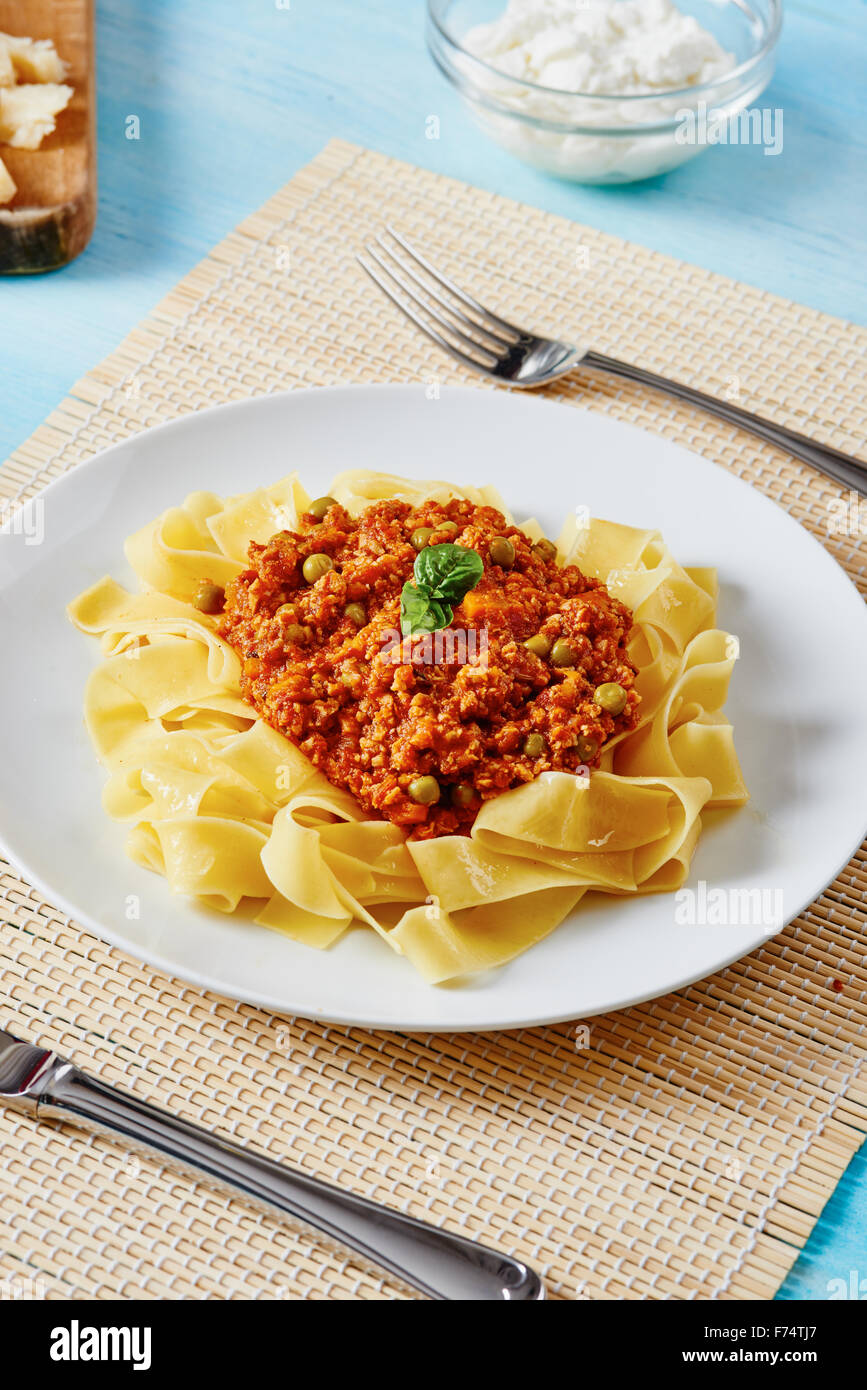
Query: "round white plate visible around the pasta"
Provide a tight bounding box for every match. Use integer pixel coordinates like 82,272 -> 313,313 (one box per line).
0,386 -> 867,1030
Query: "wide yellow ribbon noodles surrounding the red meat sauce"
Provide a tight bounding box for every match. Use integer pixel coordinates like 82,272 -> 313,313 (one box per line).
68,471 -> 748,983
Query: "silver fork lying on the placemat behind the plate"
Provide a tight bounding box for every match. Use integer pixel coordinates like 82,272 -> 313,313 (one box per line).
357,227 -> 867,496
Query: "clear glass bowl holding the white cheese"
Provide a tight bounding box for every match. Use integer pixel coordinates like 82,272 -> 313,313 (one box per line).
427,0 -> 782,183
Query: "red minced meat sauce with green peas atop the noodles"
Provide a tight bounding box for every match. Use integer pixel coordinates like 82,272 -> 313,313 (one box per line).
220,498 -> 639,838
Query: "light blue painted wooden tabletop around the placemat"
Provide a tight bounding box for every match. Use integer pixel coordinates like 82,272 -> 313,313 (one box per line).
0,0 -> 867,1298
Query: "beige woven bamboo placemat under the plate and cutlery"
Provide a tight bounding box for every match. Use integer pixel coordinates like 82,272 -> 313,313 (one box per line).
0,143 -> 867,1298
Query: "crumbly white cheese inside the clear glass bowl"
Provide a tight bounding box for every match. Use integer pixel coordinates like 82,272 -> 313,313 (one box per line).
461,0 -> 736,182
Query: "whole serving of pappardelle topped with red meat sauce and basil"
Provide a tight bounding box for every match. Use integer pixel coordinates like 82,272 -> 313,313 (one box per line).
69,471 -> 748,983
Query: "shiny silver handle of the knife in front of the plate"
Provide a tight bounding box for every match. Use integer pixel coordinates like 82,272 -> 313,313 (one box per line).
36,1059 -> 545,1302
